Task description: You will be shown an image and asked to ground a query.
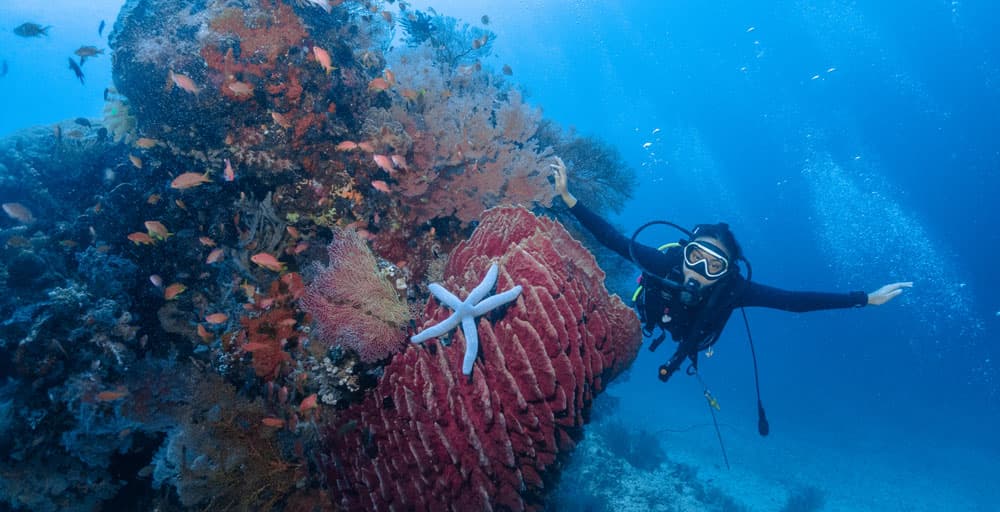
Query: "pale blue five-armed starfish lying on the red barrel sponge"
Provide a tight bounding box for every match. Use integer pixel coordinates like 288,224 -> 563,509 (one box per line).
410,262 -> 521,375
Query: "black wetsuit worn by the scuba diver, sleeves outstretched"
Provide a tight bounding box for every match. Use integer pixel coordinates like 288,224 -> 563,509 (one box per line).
570,201 -> 868,340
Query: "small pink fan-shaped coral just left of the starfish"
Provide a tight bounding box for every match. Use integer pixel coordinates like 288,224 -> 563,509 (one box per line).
302,230 -> 410,363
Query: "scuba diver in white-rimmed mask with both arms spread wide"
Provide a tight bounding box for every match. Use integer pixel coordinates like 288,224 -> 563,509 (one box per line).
550,157 -> 913,435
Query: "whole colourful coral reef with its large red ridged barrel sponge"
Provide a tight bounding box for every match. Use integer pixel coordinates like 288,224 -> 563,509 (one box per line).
0,0 -> 638,510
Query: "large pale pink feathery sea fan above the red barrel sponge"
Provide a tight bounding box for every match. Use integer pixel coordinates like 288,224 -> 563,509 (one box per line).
378,48 -> 551,225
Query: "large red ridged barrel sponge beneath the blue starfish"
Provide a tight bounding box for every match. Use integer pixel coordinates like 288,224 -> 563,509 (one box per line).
327,207 -> 642,510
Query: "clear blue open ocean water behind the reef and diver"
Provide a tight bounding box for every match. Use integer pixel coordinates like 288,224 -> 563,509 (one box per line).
0,0 -> 1000,510
